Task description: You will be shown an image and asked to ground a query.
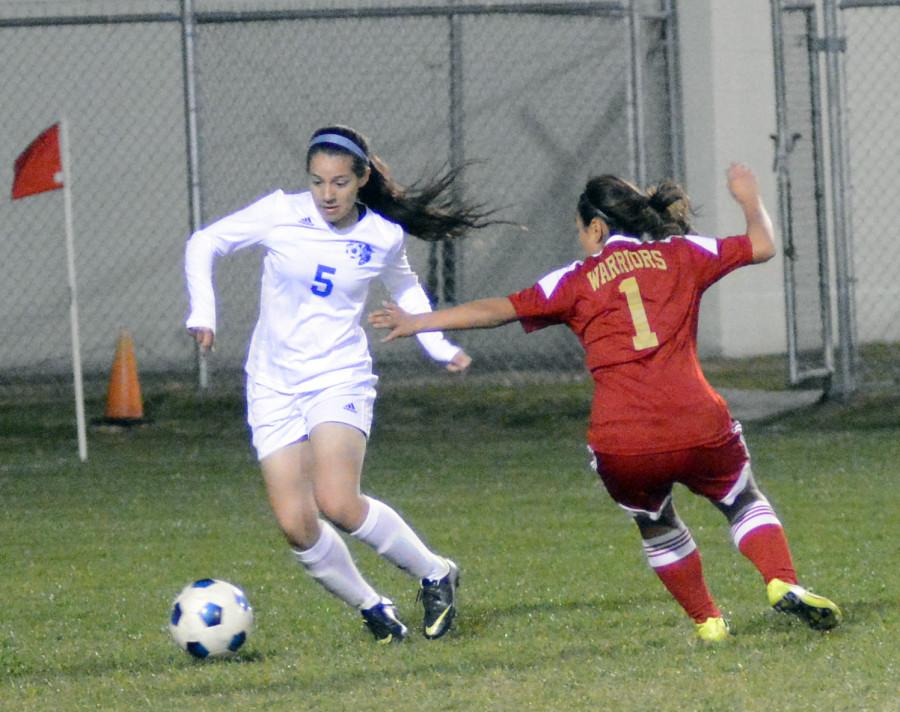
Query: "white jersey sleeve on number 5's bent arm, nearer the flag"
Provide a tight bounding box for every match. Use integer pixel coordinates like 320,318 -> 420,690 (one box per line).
184,190 -> 284,331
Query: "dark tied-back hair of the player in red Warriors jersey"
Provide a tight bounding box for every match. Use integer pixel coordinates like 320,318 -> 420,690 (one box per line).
578,175 -> 694,240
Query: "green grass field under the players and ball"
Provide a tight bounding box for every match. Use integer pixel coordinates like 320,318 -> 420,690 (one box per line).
0,382 -> 900,711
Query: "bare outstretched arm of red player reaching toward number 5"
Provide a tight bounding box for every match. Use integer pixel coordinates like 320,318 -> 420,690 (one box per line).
369,297 -> 518,341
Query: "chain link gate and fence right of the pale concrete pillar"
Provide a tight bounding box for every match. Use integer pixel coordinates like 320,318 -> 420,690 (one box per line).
772,0 -> 900,395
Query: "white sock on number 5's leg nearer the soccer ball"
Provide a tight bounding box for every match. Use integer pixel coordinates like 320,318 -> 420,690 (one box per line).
293,521 -> 381,610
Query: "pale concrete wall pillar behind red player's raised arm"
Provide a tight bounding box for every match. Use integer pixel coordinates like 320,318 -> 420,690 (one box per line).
678,0 -> 786,357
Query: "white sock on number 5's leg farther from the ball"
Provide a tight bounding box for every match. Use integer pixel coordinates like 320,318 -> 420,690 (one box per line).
351,497 -> 450,580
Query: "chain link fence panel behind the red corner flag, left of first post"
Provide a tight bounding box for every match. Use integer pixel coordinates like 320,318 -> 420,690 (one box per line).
0,3 -> 192,394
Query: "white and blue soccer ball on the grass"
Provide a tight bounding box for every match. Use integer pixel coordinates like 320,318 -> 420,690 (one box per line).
169,579 -> 253,658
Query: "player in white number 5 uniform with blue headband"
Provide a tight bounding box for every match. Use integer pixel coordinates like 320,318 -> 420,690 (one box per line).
185,126 -> 490,643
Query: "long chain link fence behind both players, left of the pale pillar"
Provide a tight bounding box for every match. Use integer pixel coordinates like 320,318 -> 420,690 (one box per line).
0,0 -> 679,394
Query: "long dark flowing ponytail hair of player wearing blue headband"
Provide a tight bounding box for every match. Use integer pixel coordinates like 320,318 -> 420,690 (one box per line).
306,125 -> 496,242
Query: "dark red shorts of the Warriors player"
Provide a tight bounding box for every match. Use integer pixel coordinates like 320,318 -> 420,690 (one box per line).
594,421 -> 750,514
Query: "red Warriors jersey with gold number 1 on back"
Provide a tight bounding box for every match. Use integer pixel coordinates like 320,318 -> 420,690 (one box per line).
509,235 -> 753,455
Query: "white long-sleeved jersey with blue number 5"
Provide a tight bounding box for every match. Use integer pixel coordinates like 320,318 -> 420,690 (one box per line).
185,190 -> 460,393
